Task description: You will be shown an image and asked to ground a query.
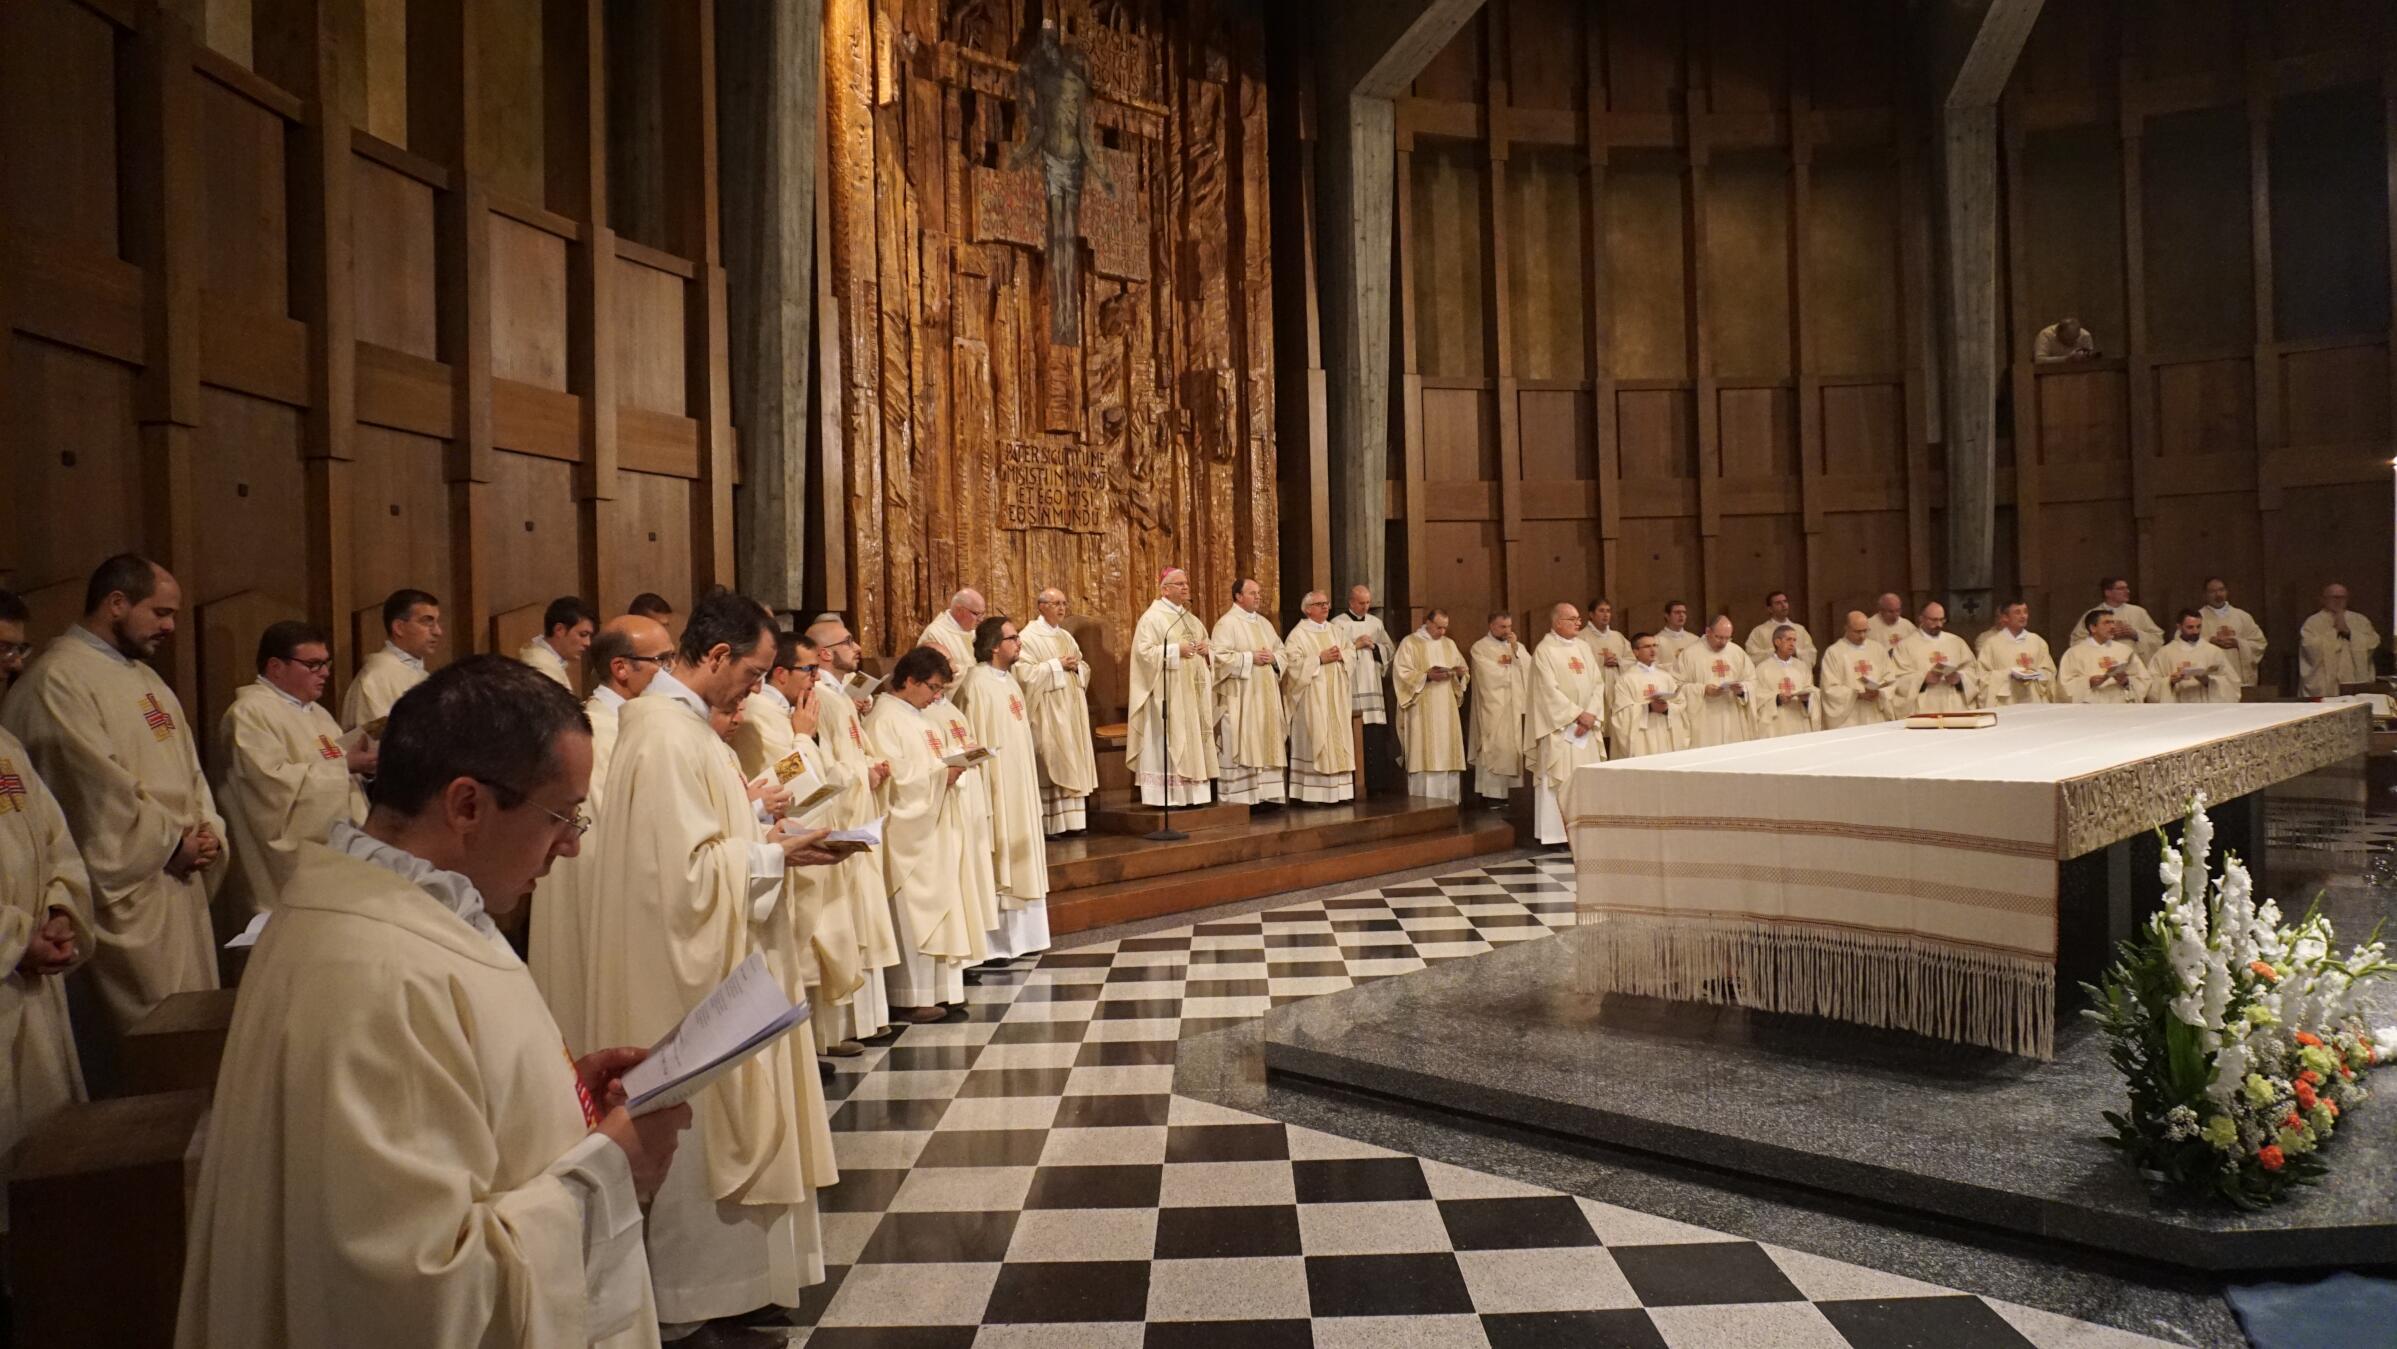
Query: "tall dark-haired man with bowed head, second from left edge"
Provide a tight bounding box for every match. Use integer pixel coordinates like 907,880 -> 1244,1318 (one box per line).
0,553 -> 228,1068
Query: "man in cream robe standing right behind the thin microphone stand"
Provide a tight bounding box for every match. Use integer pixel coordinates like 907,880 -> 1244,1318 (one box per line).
1124,568 -> 1215,805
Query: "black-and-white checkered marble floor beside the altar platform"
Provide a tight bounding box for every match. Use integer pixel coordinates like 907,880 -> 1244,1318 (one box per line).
747,858 -> 2157,1349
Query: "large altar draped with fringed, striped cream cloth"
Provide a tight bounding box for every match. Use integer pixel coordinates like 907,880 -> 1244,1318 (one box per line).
1565,702 -> 2371,1059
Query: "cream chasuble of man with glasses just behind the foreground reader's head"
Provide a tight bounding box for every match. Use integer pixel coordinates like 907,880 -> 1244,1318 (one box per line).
211,678 -> 367,937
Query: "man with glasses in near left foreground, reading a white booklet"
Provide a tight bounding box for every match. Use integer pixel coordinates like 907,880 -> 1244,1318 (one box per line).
175,657 -> 700,1349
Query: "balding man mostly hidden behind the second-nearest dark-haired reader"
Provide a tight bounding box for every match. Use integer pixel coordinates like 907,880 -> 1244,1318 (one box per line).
525,613 -> 674,1045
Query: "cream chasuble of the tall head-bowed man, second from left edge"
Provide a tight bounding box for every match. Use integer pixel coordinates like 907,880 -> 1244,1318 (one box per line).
0,628 -> 235,1044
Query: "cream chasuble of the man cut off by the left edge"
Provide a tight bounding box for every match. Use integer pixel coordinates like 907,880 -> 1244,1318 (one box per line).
0,731 -> 91,1232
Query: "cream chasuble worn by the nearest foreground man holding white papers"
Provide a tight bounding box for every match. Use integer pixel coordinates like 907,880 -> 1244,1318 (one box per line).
175,829 -> 661,1349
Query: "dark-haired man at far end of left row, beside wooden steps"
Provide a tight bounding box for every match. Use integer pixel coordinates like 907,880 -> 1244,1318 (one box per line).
966,613 -> 1050,961
